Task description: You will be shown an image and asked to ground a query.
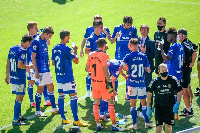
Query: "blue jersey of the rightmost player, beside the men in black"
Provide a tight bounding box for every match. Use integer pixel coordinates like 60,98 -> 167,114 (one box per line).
167,42 -> 185,80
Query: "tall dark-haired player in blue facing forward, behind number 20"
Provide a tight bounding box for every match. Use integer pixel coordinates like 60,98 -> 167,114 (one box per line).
111,16 -> 138,100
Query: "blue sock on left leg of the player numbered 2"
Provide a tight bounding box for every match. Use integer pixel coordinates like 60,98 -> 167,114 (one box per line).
58,94 -> 66,120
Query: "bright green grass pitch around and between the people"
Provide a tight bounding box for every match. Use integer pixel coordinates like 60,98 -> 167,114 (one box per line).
0,0 -> 200,133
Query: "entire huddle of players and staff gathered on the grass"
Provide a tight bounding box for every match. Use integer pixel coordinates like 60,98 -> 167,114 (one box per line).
5,15 -> 200,132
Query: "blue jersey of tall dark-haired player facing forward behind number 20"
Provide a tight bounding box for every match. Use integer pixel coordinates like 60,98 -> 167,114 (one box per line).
112,24 -> 138,60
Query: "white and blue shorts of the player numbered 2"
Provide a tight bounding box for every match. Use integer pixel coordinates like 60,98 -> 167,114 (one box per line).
57,81 -> 77,94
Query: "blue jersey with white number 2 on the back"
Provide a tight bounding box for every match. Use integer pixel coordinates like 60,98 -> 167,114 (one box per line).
51,44 -> 76,84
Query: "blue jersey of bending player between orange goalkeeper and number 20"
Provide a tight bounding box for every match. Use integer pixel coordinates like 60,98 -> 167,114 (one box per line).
108,59 -> 121,78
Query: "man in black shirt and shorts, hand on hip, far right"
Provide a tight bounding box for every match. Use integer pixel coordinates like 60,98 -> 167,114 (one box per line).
178,28 -> 197,116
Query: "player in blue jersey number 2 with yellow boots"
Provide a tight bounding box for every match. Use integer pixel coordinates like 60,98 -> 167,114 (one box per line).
52,30 -> 88,127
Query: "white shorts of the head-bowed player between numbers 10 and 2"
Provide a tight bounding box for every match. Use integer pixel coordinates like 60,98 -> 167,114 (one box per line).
35,72 -> 53,86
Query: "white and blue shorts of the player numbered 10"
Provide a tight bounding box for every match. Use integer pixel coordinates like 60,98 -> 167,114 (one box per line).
11,84 -> 26,95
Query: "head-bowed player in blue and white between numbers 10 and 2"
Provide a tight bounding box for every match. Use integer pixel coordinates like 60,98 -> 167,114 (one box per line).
32,27 -> 59,117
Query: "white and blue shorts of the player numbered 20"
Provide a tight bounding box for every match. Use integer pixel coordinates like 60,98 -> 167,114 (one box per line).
127,86 -> 147,99
